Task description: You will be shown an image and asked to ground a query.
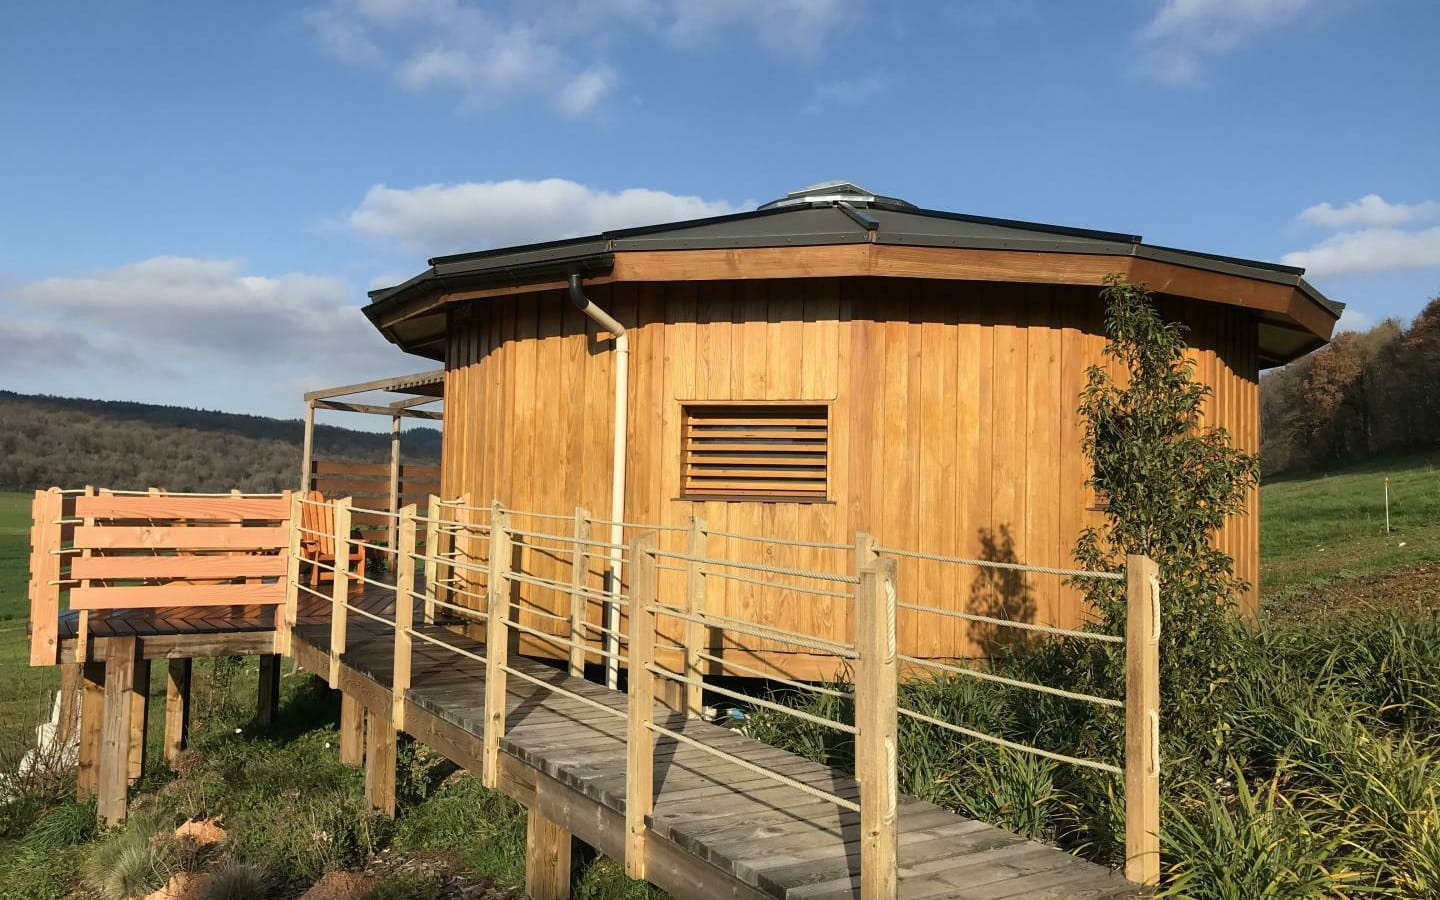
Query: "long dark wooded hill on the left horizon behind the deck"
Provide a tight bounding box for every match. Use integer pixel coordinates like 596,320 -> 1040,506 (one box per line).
0,390 -> 441,491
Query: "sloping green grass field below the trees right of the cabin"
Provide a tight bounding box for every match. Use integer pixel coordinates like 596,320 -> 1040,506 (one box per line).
1260,454 -> 1440,603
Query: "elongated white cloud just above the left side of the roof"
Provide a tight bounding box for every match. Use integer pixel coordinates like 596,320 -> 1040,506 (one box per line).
346,179 -> 750,256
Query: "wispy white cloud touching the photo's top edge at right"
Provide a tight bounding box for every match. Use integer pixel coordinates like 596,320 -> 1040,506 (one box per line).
1140,0 -> 1312,85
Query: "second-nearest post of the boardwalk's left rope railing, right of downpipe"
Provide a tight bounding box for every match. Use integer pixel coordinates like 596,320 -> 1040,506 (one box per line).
625,531 -> 660,878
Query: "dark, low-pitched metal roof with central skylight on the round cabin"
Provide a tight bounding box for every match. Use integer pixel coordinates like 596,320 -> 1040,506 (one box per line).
364,192 -> 1345,365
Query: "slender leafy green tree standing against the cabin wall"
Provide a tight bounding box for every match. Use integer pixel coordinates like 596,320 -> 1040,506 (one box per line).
1074,275 -> 1259,748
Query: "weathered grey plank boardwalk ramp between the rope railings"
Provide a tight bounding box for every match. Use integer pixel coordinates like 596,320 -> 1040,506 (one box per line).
292,595 -> 1139,900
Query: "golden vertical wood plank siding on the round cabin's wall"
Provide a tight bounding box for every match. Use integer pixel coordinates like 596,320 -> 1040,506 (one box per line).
442,278 -> 1259,661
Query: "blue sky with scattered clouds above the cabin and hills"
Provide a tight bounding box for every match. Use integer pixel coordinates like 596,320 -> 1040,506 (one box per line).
0,0 -> 1440,420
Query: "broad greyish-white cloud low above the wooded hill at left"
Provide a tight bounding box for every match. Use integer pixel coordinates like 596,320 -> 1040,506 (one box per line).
9,256 -> 406,372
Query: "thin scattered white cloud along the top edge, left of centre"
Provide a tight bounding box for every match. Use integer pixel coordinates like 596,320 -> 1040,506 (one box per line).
304,0 -> 865,117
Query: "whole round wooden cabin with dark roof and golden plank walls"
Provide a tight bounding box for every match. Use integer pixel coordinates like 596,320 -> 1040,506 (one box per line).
366,183 -> 1341,675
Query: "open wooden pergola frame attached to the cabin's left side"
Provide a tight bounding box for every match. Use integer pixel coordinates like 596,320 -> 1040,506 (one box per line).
300,369 -> 445,547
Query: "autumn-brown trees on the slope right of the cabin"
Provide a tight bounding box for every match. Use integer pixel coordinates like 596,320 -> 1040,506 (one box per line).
1260,297 -> 1440,474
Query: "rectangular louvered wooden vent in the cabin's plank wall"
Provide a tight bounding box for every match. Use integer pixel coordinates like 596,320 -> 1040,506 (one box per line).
684,406 -> 829,500
